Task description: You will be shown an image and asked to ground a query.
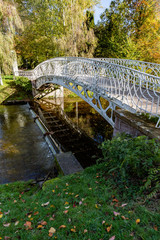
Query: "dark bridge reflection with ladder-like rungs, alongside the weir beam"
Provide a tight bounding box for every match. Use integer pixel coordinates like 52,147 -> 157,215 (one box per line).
35,102 -> 101,168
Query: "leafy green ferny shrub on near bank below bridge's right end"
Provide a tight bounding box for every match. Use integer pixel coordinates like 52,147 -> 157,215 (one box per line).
101,135 -> 160,197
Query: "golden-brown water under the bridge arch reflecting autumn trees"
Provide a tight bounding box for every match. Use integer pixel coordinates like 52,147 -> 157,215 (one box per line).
39,98 -> 113,143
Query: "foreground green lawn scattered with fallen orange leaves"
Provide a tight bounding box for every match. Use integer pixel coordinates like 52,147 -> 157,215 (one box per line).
0,163 -> 160,240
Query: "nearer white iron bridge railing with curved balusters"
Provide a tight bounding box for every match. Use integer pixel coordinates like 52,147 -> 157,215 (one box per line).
17,57 -> 160,126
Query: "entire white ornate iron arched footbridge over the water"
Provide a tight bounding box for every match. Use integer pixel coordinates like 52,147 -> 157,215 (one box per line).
18,57 -> 160,127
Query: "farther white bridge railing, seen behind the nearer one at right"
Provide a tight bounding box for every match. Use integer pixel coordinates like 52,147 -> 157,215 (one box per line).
95,58 -> 160,77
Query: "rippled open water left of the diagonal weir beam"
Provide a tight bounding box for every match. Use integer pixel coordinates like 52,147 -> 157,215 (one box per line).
0,105 -> 53,183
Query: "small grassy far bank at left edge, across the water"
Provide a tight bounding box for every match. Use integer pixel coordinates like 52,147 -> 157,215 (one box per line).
0,76 -> 32,104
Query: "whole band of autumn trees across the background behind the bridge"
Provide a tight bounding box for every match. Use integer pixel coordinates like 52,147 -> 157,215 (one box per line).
0,0 -> 160,73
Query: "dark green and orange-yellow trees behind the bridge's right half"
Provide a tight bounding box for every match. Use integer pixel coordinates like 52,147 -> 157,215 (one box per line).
95,0 -> 160,63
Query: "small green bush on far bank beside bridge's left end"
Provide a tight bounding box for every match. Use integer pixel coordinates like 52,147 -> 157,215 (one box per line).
15,77 -> 32,93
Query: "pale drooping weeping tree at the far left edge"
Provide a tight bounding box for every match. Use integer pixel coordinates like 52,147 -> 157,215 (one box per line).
0,0 -> 22,73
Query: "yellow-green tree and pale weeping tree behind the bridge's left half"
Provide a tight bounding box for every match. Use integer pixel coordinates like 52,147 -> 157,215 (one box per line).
16,0 -> 99,67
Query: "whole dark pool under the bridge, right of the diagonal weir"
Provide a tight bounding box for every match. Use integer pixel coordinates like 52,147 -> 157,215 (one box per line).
32,98 -> 113,167
